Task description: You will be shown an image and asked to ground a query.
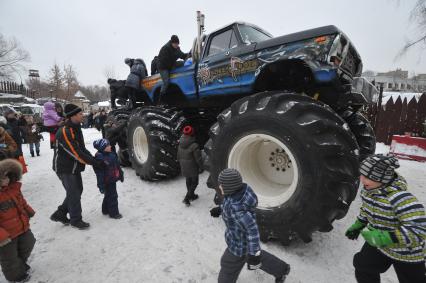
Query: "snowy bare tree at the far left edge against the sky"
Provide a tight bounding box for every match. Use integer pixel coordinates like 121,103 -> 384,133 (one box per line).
0,33 -> 30,80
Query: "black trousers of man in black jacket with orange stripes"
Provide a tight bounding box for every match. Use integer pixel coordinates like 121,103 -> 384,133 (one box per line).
58,173 -> 83,224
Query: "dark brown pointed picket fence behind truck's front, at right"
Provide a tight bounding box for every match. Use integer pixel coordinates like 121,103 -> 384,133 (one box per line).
367,93 -> 426,145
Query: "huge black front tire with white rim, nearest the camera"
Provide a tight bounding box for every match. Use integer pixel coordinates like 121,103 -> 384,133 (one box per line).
205,92 -> 359,245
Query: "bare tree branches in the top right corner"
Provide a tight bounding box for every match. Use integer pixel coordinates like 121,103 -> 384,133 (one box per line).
398,0 -> 426,56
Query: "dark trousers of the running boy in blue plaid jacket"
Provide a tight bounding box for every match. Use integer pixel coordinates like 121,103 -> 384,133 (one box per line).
218,249 -> 288,283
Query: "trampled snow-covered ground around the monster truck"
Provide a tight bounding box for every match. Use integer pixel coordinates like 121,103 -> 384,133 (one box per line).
0,129 -> 426,283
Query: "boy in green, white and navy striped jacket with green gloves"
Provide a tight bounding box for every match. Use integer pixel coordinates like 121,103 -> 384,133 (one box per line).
346,155 -> 426,283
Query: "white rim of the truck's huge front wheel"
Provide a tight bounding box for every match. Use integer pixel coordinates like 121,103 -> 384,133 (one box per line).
228,134 -> 299,209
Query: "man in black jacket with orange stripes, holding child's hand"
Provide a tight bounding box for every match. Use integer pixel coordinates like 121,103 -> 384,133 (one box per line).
50,104 -> 105,230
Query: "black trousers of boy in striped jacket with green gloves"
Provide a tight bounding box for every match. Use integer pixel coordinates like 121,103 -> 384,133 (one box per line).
354,243 -> 426,283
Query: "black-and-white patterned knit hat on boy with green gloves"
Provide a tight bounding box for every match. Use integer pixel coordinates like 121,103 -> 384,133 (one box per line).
359,154 -> 399,184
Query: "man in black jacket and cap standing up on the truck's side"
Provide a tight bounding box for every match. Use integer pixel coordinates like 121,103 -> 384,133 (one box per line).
158,35 -> 188,104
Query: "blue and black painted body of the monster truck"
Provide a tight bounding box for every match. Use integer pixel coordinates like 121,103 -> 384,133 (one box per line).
141,22 -> 363,111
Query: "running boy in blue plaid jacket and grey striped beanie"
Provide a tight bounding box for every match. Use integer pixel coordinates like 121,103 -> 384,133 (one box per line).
212,169 -> 290,283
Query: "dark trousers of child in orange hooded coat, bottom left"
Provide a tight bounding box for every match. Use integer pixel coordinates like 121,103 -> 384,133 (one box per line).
0,230 -> 36,281
